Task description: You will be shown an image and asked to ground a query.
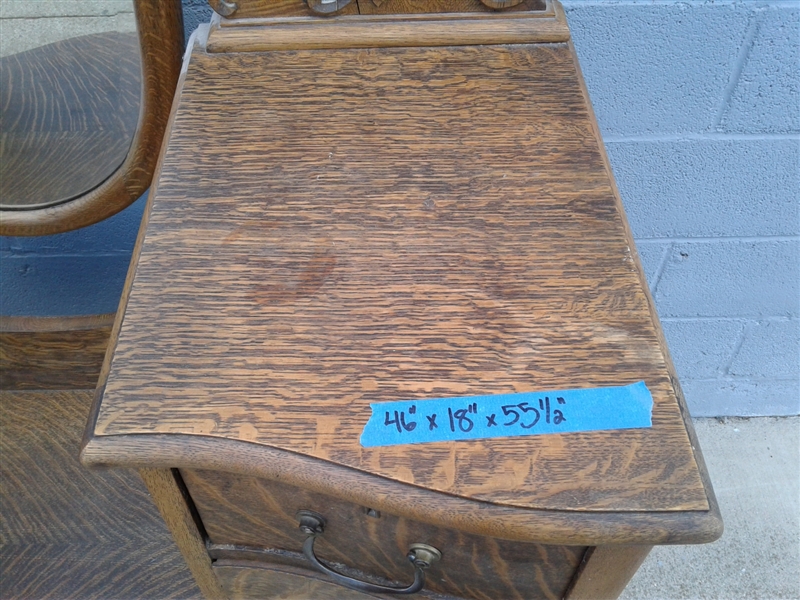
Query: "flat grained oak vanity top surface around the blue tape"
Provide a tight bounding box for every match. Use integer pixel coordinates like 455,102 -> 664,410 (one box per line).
84,37 -> 718,541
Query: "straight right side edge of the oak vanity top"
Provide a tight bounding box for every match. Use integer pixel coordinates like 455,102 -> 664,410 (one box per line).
569,41 -> 723,541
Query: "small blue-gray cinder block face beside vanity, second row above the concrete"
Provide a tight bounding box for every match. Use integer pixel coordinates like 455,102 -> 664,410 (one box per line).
661,319 -> 745,381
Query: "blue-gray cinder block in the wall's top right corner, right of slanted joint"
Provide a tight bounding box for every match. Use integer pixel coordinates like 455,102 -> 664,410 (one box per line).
720,4 -> 800,133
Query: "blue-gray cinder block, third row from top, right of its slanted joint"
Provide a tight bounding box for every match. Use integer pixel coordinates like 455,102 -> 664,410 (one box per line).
654,240 -> 800,318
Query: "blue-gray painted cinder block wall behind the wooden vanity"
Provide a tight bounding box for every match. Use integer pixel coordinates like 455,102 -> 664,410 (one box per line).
0,0 -> 800,416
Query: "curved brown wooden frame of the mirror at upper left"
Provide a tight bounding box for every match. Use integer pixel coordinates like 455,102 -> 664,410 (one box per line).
0,0 -> 183,236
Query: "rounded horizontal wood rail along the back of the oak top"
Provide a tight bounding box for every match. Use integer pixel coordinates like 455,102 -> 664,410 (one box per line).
206,0 -> 570,53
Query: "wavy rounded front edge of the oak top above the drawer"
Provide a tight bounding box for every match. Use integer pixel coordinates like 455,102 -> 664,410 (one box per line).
81,434 -> 722,546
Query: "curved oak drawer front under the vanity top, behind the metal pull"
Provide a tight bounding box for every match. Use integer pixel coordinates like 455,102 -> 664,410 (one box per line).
186,469 -> 586,599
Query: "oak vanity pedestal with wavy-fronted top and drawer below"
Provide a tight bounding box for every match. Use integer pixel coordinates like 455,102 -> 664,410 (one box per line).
82,0 -> 722,599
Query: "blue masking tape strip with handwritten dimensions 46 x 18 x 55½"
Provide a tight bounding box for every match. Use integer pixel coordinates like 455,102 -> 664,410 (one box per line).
361,381 -> 653,448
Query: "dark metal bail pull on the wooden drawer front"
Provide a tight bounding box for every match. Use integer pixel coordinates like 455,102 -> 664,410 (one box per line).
297,510 -> 442,594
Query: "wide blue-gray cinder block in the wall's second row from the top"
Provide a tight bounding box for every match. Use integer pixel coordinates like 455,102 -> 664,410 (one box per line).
607,139 -> 800,238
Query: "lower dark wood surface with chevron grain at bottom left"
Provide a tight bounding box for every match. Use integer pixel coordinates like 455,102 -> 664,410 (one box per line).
0,390 -> 200,600
